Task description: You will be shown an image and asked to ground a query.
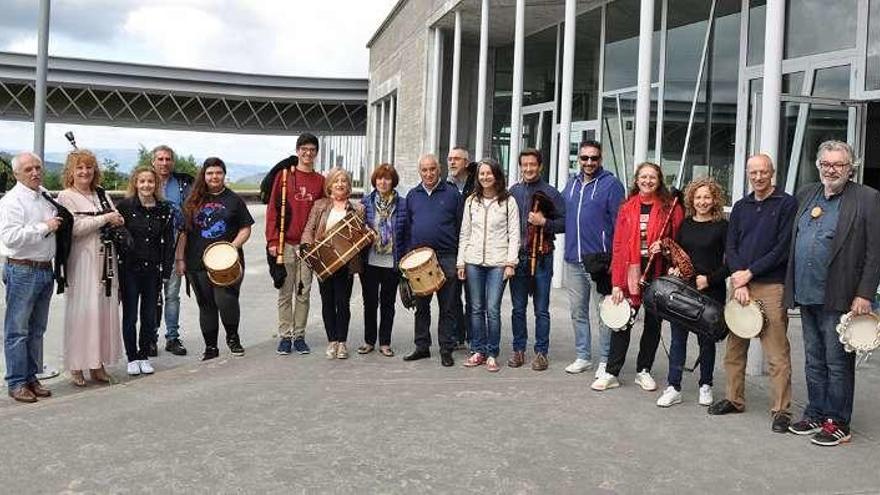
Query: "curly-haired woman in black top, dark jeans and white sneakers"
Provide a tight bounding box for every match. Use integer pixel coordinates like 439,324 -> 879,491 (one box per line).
657,177 -> 730,407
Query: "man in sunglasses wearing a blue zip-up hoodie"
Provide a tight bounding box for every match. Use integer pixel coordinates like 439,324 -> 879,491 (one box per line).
562,141 -> 625,378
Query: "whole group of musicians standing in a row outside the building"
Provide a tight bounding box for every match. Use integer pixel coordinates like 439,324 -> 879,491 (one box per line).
0,134 -> 880,445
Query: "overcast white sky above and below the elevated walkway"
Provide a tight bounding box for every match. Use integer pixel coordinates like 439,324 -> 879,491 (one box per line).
0,0 -> 395,164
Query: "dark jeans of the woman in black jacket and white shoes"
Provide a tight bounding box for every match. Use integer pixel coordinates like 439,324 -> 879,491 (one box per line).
122,265 -> 162,362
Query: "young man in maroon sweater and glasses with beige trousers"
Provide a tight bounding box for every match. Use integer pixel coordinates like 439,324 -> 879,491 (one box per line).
266,133 -> 324,355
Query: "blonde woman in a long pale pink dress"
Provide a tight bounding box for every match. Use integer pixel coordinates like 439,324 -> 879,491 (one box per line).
58,149 -> 125,387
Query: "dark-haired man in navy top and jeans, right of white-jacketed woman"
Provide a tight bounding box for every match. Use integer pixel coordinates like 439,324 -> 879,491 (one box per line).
507,148 -> 565,371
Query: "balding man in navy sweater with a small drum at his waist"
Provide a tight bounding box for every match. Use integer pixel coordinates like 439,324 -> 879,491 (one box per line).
403,155 -> 464,367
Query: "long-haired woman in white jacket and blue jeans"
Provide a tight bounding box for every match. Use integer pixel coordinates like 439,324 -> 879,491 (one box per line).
456,158 -> 519,372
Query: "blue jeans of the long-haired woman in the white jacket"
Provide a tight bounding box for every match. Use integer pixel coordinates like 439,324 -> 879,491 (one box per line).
465,264 -> 505,357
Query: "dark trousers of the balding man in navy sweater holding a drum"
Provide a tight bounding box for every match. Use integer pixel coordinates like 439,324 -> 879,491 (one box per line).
414,254 -> 458,352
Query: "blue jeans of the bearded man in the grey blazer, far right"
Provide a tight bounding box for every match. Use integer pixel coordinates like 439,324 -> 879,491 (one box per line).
801,305 -> 856,425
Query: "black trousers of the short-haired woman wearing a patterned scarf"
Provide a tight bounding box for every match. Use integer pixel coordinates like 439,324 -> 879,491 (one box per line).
361,265 -> 400,345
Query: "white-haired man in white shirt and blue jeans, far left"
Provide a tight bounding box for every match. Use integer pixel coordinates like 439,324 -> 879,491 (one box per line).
0,153 -> 61,402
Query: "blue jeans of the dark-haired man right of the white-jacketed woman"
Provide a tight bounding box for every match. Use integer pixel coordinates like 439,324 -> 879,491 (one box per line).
510,253 -> 553,354
